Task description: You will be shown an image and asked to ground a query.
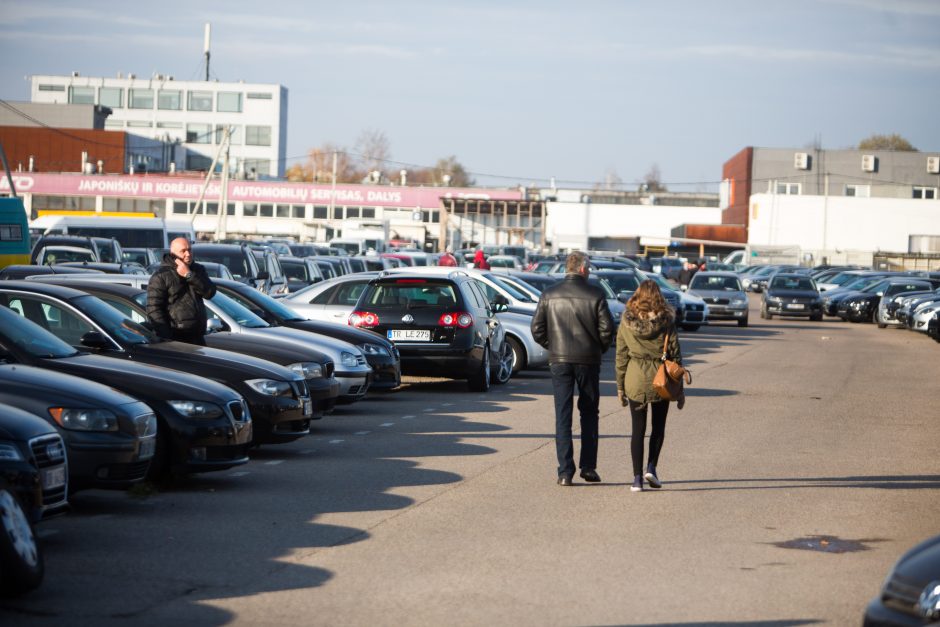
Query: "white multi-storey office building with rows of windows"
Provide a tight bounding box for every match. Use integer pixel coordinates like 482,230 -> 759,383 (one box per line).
30,72 -> 287,178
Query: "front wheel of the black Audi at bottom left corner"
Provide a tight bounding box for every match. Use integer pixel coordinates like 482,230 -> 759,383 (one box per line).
0,485 -> 44,594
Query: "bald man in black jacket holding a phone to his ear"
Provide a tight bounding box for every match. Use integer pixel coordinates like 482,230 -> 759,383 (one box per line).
147,237 -> 215,346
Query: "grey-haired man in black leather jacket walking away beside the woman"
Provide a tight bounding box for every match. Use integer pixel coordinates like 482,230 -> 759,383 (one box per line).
532,252 -> 614,486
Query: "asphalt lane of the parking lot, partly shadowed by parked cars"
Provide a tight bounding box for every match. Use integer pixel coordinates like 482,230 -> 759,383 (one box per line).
0,295 -> 940,626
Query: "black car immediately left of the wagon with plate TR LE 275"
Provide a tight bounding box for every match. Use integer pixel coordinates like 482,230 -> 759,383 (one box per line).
215,280 -> 401,390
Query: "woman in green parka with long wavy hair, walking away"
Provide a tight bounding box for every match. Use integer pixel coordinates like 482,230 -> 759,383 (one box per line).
616,280 -> 685,492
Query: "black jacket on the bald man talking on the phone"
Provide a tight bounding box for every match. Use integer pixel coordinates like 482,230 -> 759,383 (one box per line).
147,253 -> 215,338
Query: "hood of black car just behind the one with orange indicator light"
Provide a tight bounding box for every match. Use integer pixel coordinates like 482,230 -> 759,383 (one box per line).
36,354 -> 237,402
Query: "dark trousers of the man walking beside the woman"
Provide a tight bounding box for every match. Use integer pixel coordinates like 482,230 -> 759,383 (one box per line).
550,364 -> 601,477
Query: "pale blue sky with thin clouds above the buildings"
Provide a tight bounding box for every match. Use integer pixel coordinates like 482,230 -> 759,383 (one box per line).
0,0 -> 940,191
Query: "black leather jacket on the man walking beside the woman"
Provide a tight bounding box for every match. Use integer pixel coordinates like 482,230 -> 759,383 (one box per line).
532,274 -> 614,364
